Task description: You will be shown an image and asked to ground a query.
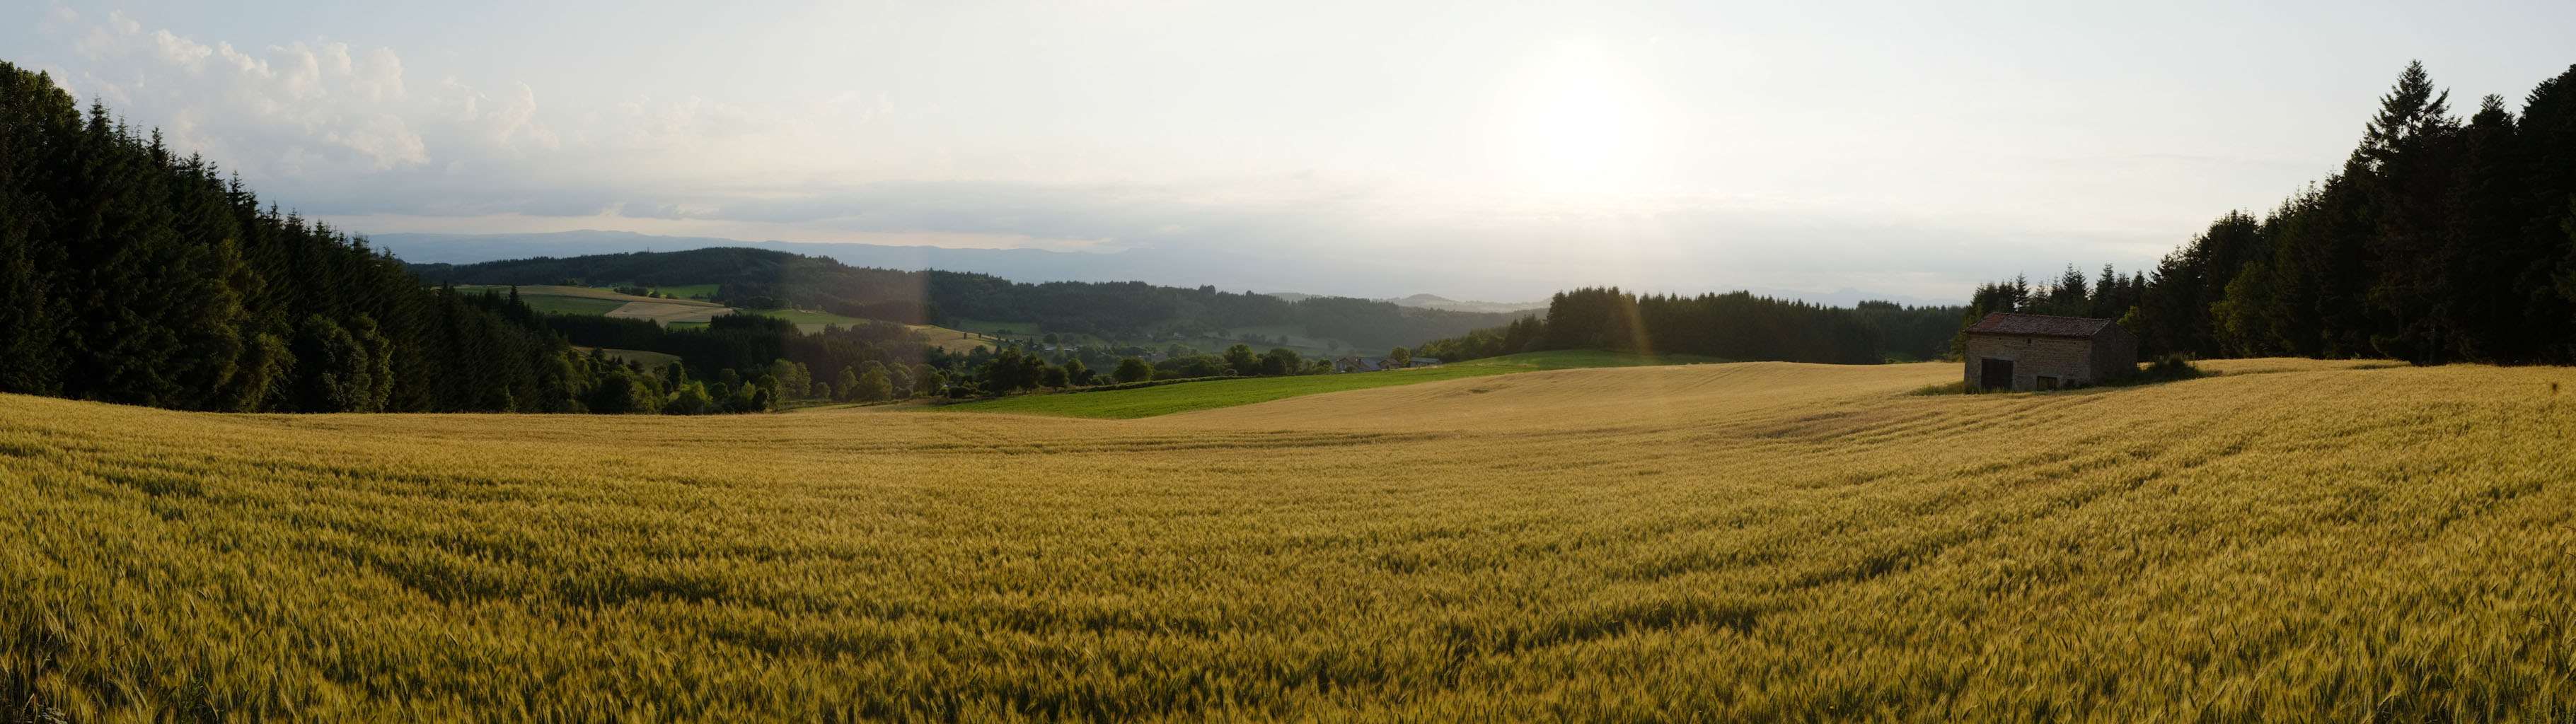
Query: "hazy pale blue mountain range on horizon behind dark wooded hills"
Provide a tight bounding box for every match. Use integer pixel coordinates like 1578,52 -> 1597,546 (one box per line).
369,229 -> 1958,312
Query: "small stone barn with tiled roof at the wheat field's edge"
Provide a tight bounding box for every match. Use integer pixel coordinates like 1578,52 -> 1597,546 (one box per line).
1963,312 -> 2138,392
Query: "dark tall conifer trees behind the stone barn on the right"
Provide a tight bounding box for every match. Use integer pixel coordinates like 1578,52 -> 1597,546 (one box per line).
1973,62 -> 2576,363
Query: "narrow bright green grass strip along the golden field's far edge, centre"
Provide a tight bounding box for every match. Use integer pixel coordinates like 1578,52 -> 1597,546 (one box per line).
927,351 -> 1711,420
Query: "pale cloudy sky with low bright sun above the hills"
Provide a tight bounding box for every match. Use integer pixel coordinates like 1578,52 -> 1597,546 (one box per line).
0,0 -> 2576,301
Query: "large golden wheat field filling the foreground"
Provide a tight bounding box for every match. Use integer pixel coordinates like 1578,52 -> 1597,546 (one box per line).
0,361 -> 2576,721
